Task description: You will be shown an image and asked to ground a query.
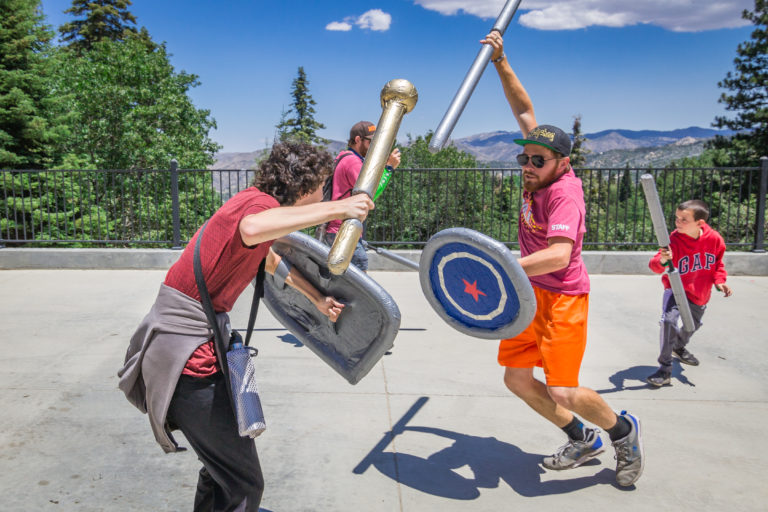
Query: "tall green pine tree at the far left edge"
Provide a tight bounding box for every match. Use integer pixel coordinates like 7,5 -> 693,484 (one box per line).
0,0 -> 53,169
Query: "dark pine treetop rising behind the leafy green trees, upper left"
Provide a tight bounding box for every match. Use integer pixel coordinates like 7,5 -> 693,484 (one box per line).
59,0 -> 140,52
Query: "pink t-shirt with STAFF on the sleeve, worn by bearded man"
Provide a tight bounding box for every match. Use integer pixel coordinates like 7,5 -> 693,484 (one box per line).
518,169 -> 589,295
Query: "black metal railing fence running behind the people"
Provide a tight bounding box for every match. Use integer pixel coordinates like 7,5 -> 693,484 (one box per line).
0,157 -> 768,252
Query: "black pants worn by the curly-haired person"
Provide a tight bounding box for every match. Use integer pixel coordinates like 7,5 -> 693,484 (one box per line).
168,372 -> 264,512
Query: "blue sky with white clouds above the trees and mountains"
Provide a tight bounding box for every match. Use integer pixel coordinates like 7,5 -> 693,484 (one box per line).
42,0 -> 754,152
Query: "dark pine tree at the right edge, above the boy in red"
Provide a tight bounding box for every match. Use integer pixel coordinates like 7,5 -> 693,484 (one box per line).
711,0 -> 768,166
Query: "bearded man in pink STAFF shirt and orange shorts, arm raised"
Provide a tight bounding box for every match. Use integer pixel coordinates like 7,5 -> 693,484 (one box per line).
480,31 -> 643,486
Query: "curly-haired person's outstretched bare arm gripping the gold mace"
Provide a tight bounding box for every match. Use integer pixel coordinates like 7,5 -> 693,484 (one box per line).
240,194 -> 373,246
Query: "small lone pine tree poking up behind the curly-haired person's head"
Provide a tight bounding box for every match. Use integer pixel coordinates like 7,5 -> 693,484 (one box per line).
276,66 -> 328,144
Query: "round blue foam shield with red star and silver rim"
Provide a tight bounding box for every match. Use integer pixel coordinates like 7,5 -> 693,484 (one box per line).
419,228 -> 536,340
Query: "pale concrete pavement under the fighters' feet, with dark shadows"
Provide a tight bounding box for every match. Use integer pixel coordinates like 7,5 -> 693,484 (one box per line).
0,270 -> 768,512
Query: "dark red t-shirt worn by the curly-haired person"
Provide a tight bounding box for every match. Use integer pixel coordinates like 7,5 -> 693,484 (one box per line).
165,187 -> 280,377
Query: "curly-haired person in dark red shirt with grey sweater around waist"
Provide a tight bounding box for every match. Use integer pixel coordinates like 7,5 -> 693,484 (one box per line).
118,142 -> 373,512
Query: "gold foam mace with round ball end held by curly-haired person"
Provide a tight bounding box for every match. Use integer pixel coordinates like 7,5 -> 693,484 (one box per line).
328,78 -> 419,275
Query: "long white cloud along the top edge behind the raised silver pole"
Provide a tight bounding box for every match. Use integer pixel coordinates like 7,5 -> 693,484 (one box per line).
414,0 -> 755,32
